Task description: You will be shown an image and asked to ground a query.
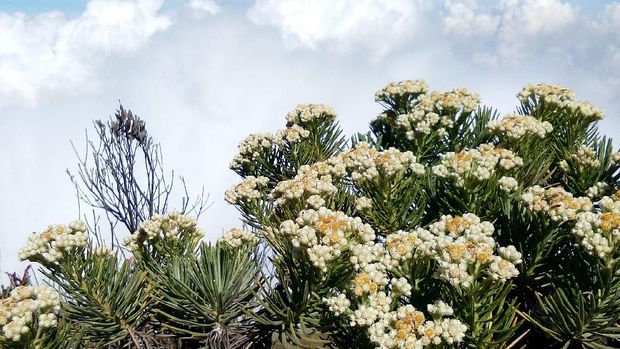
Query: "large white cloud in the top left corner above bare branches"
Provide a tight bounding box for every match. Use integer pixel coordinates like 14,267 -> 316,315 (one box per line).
0,0 -> 171,105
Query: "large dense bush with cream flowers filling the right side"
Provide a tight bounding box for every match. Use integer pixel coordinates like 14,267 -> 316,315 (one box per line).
227,80 -> 620,348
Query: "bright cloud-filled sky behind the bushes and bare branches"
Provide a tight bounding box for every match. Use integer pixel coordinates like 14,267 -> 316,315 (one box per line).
0,0 -> 620,278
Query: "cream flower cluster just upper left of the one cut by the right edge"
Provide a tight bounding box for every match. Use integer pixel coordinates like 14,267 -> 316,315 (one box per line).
521,185 -> 592,222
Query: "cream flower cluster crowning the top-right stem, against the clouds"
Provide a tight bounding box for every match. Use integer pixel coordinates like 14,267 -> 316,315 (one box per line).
517,83 -> 604,120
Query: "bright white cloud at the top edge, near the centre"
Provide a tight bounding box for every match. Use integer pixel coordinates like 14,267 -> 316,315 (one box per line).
248,0 -> 432,57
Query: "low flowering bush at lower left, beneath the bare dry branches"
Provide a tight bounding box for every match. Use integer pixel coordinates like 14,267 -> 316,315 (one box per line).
0,212 -> 260,349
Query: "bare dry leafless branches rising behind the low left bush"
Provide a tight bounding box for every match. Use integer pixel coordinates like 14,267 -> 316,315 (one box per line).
67,105 -> 208,238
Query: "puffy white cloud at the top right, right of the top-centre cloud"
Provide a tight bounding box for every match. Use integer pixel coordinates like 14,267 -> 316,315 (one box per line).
443,0 -> 579,64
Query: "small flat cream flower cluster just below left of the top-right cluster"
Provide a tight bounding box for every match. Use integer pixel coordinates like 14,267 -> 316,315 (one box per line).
487,114 -> 553,141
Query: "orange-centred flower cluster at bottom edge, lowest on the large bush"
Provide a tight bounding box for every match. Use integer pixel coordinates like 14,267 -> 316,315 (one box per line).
368,301 -> 467,349
